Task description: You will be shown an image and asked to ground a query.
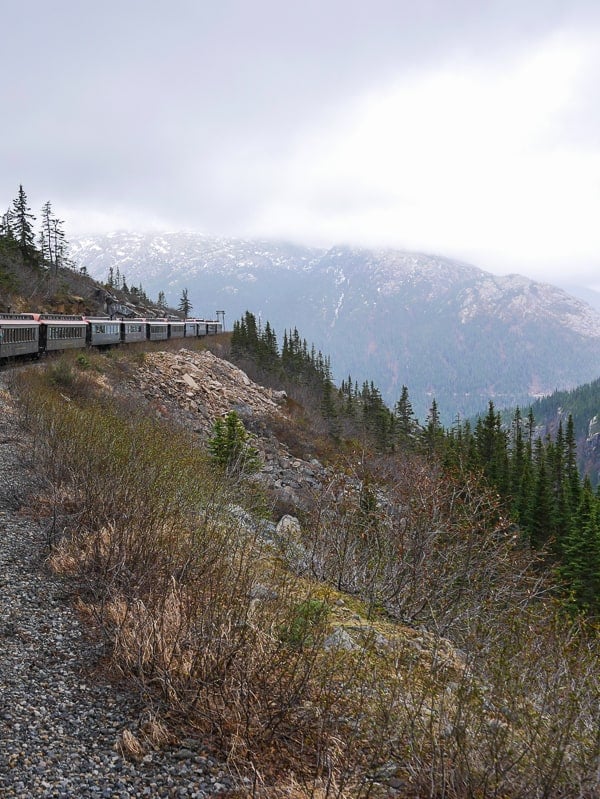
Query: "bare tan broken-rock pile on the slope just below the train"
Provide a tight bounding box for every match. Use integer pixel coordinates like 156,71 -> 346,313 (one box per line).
119,349 -> 328,508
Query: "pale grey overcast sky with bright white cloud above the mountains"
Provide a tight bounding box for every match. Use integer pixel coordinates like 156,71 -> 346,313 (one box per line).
0,0 -> 600,288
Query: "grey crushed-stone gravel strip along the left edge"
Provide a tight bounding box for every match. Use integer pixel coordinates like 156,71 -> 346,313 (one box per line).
0,373 -> 240,799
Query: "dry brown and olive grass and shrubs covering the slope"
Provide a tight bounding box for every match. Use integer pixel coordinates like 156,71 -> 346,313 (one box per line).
10,362 -> 600,799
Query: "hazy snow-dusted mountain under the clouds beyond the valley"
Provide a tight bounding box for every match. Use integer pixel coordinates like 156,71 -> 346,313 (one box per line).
72,232 -> 600,423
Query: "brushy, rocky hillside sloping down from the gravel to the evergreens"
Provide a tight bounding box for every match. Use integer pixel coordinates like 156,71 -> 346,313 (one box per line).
5,340 -> 600,799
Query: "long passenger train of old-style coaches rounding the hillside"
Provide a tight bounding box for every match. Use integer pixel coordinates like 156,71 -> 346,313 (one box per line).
0,313 -> 223,363
